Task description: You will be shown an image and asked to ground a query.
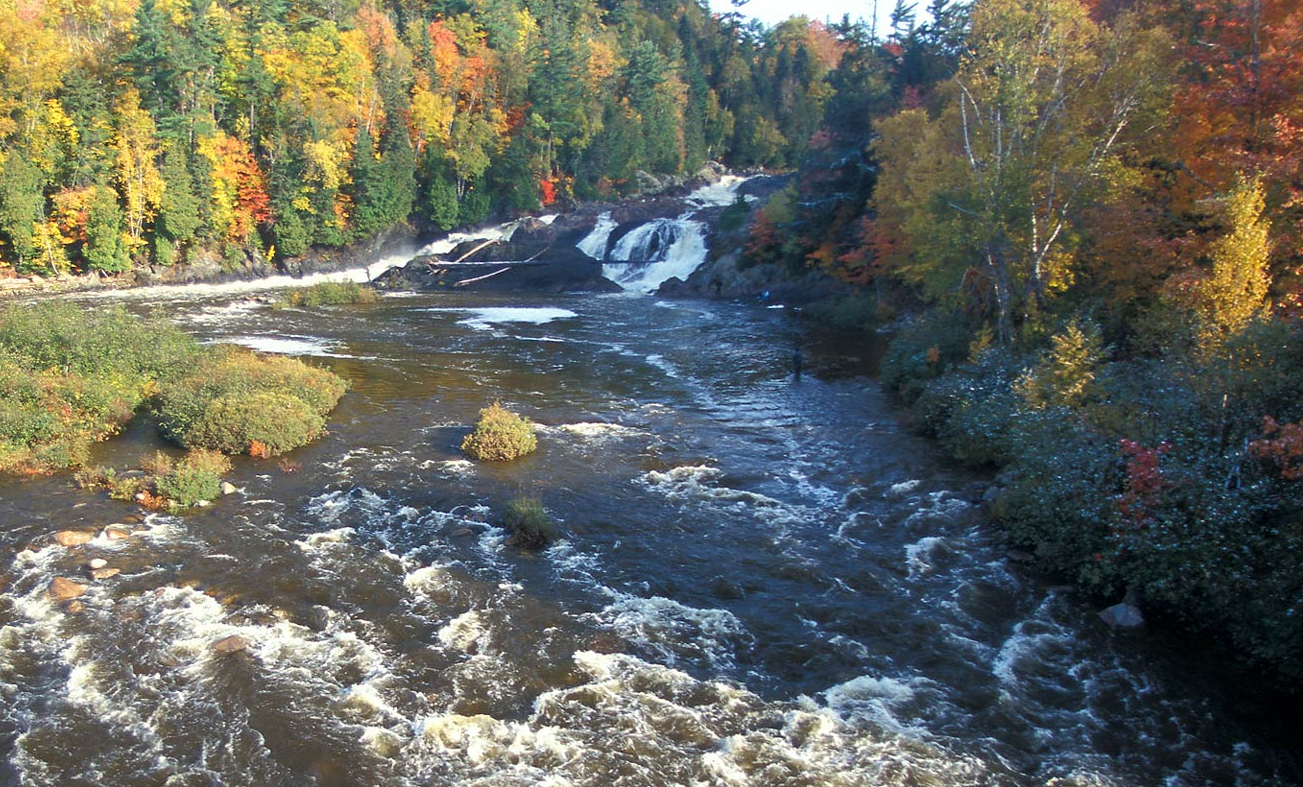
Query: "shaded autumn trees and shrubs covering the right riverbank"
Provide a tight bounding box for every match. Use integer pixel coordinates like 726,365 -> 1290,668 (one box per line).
749,0 -> 1303,688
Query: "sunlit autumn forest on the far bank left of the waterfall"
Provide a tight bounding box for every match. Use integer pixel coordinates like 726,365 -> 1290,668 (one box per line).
0,0 -> 846,275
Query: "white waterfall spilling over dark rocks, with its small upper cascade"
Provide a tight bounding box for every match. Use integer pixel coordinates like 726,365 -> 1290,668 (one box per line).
579,175 -> 747,293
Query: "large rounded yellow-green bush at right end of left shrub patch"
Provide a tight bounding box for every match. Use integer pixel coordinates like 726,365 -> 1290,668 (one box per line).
155,348 -> 345,456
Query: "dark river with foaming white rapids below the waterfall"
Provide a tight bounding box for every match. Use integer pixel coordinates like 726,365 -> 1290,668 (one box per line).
0,282 -> 1294,787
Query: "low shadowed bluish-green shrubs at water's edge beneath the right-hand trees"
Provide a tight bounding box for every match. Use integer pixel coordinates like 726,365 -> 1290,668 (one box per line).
881,310 -> 1303,688
